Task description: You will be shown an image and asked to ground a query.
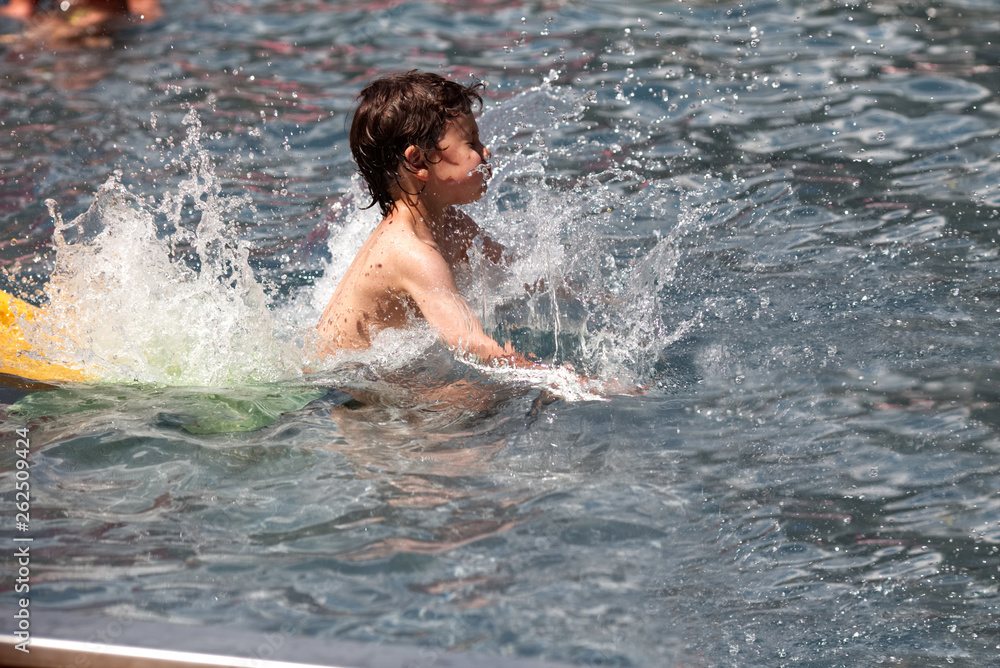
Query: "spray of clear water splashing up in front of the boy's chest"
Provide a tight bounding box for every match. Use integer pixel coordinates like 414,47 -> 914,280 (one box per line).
477,83 -> 709,389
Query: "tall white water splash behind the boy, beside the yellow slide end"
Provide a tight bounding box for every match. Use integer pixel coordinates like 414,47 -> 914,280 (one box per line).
23,110 -> 300,386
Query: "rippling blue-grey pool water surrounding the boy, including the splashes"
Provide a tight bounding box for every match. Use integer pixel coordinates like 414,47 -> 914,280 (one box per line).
0,0 -> 1000,666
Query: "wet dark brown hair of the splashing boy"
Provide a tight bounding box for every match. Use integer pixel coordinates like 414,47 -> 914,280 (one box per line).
351,70 -> 484,216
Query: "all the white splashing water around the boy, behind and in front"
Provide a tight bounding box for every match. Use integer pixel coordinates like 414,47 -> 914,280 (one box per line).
15,83 -> 702,399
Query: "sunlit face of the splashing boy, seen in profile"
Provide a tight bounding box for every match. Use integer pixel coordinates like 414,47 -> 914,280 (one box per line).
427,114 -> 492,204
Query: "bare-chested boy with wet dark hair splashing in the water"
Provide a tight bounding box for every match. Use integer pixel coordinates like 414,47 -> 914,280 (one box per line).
317,70 -> 536,367
